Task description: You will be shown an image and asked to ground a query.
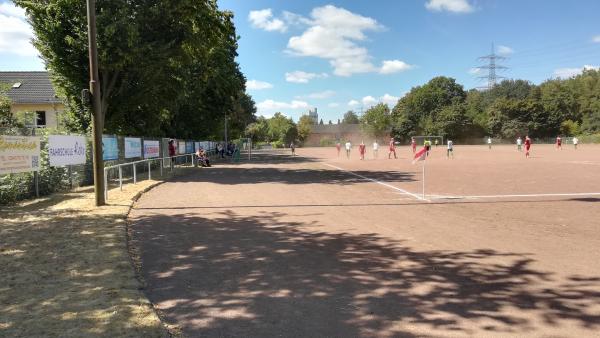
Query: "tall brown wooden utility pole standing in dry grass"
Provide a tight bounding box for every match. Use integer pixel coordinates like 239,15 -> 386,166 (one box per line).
87,0 -> 106,206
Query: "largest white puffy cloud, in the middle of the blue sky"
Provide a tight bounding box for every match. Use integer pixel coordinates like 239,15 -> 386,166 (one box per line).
287,5 -> 383,76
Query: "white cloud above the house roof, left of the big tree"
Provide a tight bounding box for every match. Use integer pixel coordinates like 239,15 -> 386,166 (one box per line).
0,2 -> 39,56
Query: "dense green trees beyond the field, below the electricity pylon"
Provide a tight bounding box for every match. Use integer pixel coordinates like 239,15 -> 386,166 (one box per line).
390,70 -> 600,140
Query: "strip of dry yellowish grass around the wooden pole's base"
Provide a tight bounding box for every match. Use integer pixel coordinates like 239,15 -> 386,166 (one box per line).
0,170 -> 195,337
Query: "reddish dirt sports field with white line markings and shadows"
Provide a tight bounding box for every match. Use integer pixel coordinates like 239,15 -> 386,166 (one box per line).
130,145 -> 600,337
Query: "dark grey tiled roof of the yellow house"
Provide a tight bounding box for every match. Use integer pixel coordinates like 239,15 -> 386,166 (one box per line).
0,72 -> 62,103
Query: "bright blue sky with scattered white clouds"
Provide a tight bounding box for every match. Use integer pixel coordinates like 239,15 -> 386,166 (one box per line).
0,0 -> 600,122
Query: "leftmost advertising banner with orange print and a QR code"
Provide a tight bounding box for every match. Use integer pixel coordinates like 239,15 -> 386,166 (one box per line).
0,136 -> 40,174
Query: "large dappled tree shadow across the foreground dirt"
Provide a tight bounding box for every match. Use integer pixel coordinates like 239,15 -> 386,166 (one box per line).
130,211 -> 600,337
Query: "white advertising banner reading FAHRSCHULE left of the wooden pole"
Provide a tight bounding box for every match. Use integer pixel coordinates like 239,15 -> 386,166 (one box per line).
48,135 -> 86,167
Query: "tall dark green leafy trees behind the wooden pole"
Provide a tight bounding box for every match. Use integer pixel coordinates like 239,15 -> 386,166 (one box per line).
14,0 -> 256,138
